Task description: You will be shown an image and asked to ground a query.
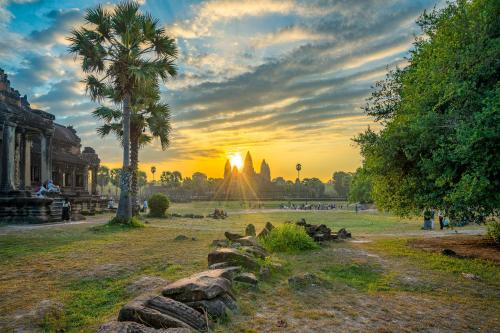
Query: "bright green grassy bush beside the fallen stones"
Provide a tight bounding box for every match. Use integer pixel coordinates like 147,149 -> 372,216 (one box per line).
262,223 -> 318,252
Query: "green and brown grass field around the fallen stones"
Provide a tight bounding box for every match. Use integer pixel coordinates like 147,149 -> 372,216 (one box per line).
0,202 -> 500,332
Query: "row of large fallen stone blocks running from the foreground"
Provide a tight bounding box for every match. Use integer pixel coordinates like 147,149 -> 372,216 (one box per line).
97,223 -> 274,333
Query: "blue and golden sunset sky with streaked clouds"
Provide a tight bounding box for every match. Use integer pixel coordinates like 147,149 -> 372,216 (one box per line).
0,0 -> 439,181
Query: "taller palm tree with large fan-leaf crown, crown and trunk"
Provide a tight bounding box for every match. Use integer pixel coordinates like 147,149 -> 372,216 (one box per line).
68,1 -> 177,221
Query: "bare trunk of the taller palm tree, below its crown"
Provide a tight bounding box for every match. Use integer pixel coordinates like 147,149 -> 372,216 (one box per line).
116,95 -> 132,221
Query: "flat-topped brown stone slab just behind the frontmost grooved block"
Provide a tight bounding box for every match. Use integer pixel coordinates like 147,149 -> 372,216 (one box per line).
162,271 -> 232,302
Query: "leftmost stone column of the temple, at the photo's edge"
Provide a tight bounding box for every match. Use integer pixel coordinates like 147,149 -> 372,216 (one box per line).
0,121 -> 16,192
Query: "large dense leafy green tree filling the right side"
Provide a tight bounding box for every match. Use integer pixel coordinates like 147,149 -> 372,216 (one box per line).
355,0 -> 500,222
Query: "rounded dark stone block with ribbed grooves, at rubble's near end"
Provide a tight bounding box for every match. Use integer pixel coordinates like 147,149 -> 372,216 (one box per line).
118,295 -> 207,331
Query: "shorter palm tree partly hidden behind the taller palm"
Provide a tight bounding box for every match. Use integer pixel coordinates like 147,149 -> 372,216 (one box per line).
93,98 -> 171,214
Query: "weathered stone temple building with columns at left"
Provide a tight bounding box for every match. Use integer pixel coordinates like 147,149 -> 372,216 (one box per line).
0,69 -> 102,223
